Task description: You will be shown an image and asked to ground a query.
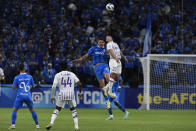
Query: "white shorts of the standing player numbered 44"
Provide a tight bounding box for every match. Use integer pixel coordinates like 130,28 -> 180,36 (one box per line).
56,97 -> 76,108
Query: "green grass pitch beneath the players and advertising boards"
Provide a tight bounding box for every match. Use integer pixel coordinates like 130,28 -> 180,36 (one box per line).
0,108 -> 196,131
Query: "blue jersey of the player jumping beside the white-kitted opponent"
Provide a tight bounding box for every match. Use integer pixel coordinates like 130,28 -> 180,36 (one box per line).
88,46 -> 108,65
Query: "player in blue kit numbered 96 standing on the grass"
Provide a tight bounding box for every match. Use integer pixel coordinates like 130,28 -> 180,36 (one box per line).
9,64 -> 39,129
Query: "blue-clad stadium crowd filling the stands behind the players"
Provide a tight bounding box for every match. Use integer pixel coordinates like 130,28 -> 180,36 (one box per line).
0,0 -> 196,87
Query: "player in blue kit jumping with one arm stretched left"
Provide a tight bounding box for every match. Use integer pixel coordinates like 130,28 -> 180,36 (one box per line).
73,39 -> 110,99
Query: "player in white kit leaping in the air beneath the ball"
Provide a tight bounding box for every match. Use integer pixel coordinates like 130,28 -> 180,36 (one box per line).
104,36 -> 128,98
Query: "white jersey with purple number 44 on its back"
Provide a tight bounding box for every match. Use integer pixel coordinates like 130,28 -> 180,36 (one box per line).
52,71 -> 79,100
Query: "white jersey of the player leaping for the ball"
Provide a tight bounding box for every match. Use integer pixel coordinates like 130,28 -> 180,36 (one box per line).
107,41 -> 121,59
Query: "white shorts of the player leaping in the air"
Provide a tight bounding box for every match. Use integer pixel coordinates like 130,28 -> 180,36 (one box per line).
109,59 -> 122,74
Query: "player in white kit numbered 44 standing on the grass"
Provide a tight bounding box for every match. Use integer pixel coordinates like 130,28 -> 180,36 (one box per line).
46,62 -> 82,131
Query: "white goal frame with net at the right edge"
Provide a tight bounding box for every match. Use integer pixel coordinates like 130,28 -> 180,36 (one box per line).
140,54 -> 196,110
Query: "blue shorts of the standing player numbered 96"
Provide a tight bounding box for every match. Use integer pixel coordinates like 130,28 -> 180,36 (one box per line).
14,95 -> 33,109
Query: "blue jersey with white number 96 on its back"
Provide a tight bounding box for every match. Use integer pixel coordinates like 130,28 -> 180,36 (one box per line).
13,73 -> 35,96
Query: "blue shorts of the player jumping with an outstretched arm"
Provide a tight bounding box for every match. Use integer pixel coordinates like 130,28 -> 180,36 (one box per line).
94,64 -> 110,80
